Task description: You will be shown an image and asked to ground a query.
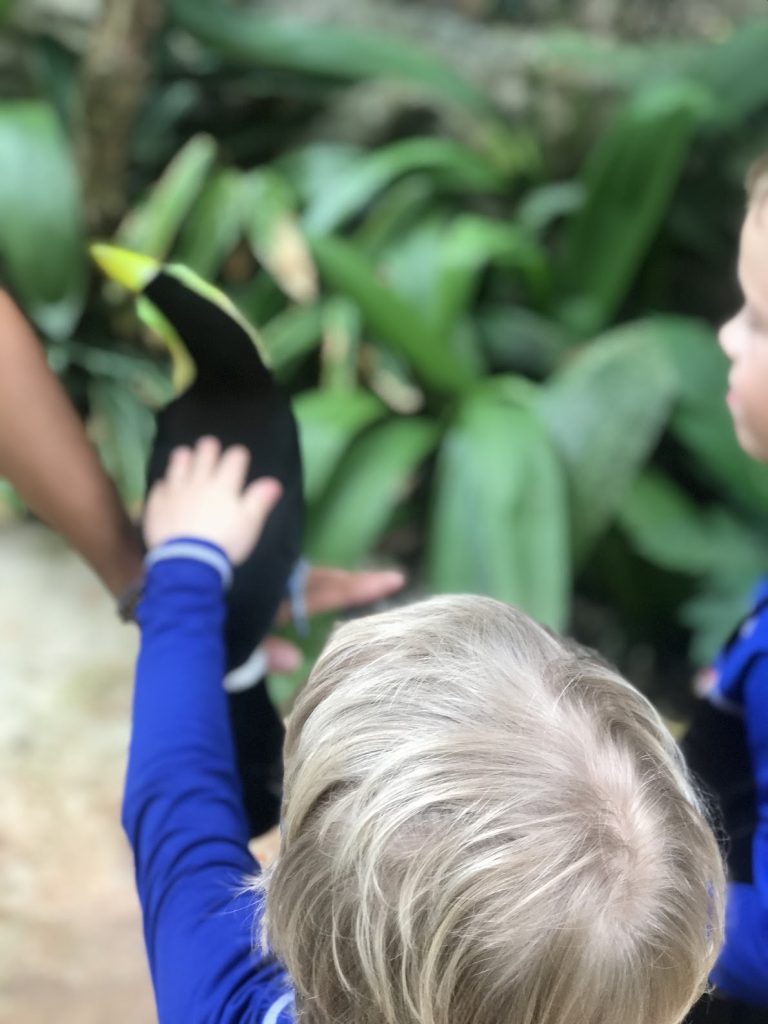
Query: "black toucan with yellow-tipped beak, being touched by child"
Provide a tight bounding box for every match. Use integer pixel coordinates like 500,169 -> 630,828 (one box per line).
91,244 -> 303,836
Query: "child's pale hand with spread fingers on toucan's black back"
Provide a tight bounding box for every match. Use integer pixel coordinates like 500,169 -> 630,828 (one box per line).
144,437 -> 282,565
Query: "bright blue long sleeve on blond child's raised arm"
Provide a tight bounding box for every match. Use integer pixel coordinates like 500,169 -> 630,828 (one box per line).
123,545 -> 293,1024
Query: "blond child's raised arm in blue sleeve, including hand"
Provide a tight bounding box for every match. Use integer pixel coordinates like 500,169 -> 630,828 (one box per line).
123,438 -> 290,1024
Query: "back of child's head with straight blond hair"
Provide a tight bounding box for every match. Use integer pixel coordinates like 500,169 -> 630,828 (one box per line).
266,597 -> 723,1024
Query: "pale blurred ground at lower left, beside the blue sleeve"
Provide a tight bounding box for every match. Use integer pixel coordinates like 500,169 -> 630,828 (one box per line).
0,523 -> 269,1024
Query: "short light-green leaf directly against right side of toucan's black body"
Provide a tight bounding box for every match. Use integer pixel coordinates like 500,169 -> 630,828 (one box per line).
293,391 -> 386,504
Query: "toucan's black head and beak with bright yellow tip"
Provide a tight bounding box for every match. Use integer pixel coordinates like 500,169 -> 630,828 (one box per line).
90,243 -> 270,393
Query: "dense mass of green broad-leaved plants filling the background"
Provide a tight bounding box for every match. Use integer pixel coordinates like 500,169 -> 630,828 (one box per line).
0,0 -> 768,708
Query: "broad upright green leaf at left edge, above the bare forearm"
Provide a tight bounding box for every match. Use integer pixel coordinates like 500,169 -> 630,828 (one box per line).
0,100 -> 87,339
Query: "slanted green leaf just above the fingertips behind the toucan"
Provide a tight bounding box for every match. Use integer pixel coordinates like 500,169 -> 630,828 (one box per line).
306,418 -> 439,565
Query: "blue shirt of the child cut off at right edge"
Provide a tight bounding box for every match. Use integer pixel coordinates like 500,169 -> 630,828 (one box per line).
710,581 -> 768,1007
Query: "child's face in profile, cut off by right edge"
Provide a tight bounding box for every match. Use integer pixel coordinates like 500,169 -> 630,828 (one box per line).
720,200 -> 768,462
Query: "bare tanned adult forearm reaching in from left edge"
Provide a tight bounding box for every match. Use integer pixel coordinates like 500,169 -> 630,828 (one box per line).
0,289 -> 141,596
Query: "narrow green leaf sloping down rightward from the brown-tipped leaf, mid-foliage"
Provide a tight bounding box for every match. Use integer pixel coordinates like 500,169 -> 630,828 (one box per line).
312,238 -> 471,394
